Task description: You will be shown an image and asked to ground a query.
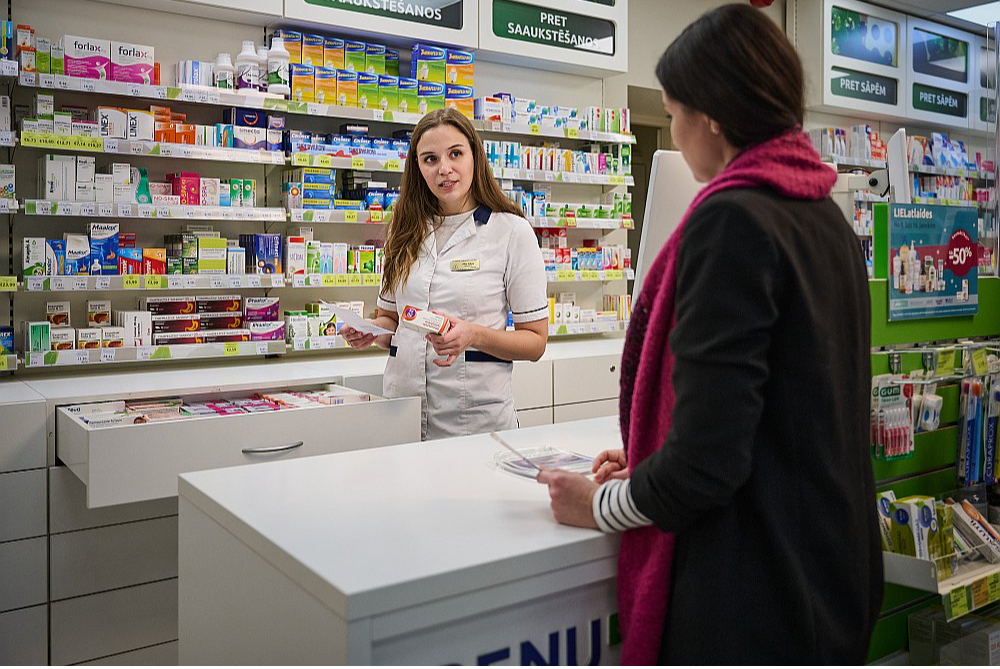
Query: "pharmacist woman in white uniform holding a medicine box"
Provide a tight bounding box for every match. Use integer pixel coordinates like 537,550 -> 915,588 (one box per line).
341,109 -> 549,439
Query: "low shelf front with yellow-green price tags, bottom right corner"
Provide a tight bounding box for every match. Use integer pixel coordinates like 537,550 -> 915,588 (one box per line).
882,552 -> 1000,621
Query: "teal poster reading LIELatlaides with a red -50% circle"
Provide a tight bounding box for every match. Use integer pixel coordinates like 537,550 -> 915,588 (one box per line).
888,204 -> 979,321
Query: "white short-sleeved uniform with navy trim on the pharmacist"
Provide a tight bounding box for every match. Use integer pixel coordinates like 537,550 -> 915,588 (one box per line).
378,206 -> 549,439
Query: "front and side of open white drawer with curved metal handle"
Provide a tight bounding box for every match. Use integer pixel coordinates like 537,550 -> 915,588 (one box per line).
56,391 -> 420,509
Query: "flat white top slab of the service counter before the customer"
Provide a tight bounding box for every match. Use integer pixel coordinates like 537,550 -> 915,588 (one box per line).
178,417 -> 621,620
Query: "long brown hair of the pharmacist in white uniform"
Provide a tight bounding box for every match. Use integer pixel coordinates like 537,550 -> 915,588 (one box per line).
382,107 -> 524,290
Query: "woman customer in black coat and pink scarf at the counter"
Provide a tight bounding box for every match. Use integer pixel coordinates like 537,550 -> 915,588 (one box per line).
539,3 -> 882,665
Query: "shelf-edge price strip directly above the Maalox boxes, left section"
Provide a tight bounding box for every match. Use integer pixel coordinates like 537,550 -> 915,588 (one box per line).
24,200 -> 288,221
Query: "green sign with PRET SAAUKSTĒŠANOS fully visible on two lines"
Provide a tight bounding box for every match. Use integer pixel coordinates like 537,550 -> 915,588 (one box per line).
494,0 -> 615,56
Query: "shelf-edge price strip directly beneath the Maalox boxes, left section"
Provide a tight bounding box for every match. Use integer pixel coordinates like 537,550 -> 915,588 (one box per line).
24,274 -> 285,293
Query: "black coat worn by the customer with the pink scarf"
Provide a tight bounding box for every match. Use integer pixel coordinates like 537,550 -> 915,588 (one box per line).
632,189 -> 882,664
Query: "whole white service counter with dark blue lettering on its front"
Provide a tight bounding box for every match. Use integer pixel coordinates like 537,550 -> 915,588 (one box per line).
179,418 -> 621,664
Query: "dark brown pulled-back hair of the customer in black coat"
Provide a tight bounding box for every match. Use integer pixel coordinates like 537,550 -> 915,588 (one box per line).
656,4 -> 803,149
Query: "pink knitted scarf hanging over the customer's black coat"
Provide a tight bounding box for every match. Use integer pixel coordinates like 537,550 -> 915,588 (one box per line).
618,129 -> 837,665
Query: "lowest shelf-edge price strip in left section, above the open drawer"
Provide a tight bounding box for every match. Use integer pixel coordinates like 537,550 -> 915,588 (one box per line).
24,341 -> 285,368
